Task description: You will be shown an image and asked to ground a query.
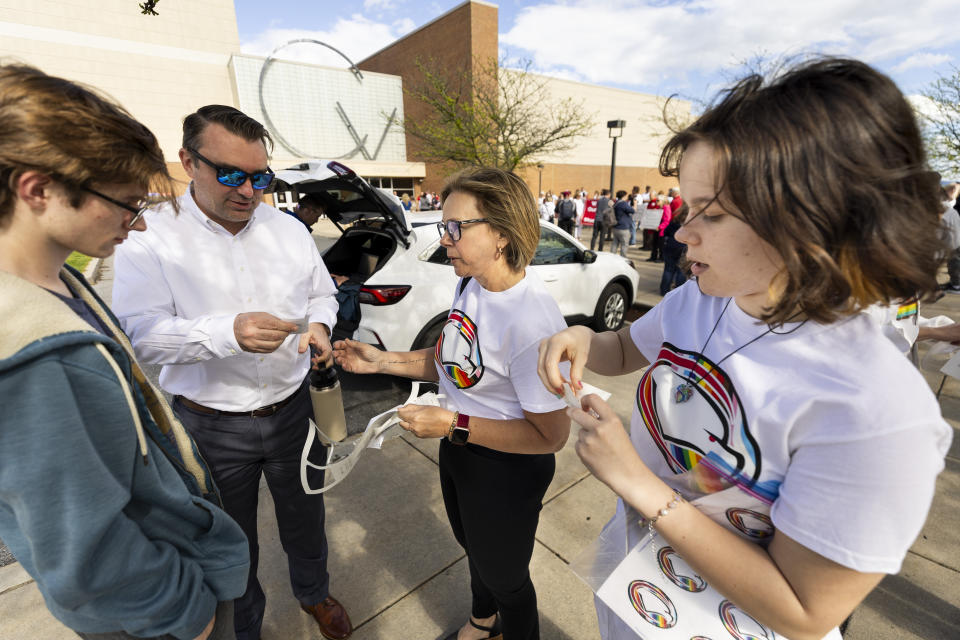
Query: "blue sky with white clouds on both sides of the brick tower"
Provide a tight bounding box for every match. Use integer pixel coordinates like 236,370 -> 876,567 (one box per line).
234,0 -> 960,100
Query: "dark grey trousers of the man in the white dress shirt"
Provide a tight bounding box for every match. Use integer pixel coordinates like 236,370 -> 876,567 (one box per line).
173,380 -> 330,640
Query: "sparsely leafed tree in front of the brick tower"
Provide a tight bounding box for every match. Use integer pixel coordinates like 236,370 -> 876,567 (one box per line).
402,58 -> 593,171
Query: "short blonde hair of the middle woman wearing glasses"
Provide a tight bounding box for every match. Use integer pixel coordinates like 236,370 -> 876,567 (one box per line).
442,167 -> 540,272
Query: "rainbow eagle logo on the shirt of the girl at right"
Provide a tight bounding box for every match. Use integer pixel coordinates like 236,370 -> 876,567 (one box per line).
637,342 -> 779,504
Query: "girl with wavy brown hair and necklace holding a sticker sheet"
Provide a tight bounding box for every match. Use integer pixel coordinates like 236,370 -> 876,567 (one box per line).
539,58 -> 951,640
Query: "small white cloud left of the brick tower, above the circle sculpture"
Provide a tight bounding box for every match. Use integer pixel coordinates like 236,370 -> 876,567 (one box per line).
240,14 -> 409,67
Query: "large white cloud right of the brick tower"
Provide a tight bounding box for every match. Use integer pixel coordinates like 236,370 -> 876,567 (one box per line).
500,0 -> 960,97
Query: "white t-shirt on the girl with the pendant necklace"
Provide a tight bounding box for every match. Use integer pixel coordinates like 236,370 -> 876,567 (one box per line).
597,281 -> 952,640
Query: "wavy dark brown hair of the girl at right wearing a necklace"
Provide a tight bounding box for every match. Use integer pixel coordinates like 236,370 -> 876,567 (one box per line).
660,58 -> 945,324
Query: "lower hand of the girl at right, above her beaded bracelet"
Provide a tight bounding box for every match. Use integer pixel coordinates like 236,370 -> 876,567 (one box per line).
567,393 -> 647,496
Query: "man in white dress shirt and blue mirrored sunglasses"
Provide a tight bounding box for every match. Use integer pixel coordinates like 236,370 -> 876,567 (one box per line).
113,105 -> 352,640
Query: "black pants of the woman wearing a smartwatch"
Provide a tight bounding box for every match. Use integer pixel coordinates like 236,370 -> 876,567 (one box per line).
440,440 -> 556,640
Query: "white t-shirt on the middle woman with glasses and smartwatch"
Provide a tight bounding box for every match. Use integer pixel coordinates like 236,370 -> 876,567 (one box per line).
434,270 -> 567,420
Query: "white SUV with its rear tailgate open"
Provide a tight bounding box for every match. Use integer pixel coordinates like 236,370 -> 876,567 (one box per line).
276,161 -> 639,351
